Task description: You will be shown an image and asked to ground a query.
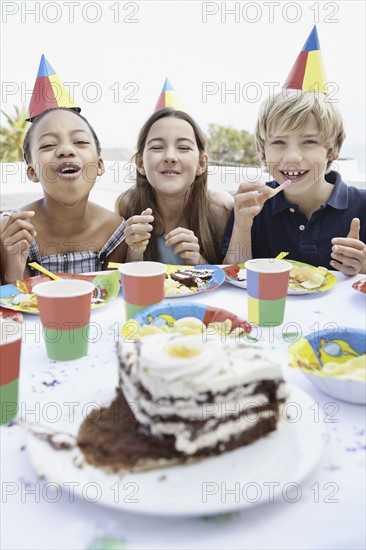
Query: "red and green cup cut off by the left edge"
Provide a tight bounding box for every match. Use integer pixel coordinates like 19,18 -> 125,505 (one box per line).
0,319 -> 22,424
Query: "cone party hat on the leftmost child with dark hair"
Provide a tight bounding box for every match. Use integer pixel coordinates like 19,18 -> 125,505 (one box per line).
26,55 -> 81,122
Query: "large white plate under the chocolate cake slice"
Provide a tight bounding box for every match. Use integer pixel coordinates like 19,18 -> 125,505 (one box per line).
27,386 -> 326,520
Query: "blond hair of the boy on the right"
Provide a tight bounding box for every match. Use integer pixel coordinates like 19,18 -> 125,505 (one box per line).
255,90 -> 346,169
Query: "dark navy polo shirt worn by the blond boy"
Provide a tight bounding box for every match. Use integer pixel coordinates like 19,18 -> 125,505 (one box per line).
222,171 -> 366,269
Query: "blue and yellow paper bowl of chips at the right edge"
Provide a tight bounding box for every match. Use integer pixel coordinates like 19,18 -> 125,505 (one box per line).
288,328 -> 366,404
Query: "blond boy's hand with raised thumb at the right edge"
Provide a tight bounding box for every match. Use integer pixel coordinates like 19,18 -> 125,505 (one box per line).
330,218 -> 366,275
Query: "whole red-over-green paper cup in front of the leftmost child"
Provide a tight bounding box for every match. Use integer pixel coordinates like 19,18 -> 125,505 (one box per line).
33,279 -> 95,361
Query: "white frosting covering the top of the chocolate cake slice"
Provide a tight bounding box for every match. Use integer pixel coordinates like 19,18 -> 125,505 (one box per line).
120,334 -> 282,401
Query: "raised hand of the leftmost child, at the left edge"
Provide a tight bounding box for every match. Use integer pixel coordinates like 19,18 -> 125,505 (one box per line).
0,210 -> 37,282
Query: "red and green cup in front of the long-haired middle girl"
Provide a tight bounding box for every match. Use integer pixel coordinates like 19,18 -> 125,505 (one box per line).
118,262 -> 166,320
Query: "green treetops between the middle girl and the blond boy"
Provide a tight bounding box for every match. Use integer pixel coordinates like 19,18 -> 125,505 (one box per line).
207,124 -> 260,166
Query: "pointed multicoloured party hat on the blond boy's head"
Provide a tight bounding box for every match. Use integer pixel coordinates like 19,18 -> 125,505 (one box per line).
283,26 -> 327,94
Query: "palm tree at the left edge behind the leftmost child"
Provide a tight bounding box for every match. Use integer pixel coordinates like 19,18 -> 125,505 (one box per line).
0,106 -> 29,162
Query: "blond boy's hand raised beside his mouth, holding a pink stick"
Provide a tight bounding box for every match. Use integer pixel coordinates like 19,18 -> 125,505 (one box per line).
234,182 -> 273,229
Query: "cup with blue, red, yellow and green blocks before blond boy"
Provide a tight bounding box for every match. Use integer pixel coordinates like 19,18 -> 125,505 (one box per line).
245,258 -> 293,327
